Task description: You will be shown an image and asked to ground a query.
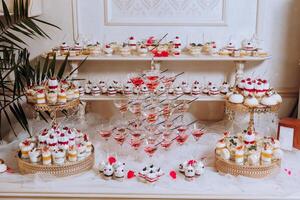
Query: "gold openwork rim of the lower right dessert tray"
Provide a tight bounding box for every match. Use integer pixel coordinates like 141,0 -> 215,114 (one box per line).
215,157 -> 281,178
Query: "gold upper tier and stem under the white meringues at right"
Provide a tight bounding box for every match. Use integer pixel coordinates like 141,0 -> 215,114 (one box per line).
225,101 -> 281,131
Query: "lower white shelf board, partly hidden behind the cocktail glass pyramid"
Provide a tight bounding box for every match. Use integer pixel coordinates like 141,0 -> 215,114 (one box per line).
80,94 -> 225,101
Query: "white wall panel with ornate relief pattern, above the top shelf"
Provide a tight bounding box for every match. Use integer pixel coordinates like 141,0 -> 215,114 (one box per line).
104,0 -> 227,26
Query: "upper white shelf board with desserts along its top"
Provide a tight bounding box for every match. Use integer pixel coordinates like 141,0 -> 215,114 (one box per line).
43,54 -> 271,61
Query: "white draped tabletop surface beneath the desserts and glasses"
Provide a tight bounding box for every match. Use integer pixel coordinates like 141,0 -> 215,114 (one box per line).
0,114 -> 300,199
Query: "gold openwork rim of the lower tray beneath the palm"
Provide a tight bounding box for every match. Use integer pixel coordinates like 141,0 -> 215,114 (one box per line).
17,148 -> 95,177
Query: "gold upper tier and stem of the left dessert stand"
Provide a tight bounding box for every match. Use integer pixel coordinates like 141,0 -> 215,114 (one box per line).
33,99 -> 80,124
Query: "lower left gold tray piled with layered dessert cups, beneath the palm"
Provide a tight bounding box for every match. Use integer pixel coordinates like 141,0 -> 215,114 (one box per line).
18,126 -> 94,176
